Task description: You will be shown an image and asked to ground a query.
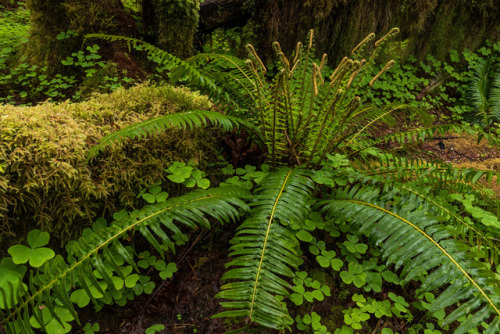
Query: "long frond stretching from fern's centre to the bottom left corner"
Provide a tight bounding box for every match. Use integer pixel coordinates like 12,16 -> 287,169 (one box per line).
0,186 -> 249,334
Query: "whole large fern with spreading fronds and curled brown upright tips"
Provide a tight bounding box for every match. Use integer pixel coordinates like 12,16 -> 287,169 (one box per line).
0,30 -> 500,333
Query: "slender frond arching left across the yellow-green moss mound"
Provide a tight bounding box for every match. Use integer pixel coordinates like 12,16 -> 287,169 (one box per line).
87,110 -> 264,159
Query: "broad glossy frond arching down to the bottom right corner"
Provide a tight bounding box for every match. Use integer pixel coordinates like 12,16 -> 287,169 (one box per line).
324,186 -> 500,333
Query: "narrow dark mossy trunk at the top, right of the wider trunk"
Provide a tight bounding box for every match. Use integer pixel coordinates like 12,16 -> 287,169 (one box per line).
154,0 -> 200,58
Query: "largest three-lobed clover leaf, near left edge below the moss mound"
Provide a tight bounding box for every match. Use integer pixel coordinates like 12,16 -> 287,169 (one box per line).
8,230 -> 56,268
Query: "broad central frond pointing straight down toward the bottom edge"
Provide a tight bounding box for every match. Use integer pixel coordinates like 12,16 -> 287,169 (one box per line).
215,168 -> 312,329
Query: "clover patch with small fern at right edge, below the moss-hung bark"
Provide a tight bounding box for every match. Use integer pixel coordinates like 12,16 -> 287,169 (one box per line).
365,42 -> 500,124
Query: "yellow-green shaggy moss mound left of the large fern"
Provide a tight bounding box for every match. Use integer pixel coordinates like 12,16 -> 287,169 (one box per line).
0,85 -> 213,250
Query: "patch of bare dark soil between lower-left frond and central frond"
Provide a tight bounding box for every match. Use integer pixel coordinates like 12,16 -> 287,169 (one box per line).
73,226 -> 233,334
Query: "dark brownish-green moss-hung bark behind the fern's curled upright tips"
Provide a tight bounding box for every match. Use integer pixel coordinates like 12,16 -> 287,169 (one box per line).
254,0 -> 500,62
